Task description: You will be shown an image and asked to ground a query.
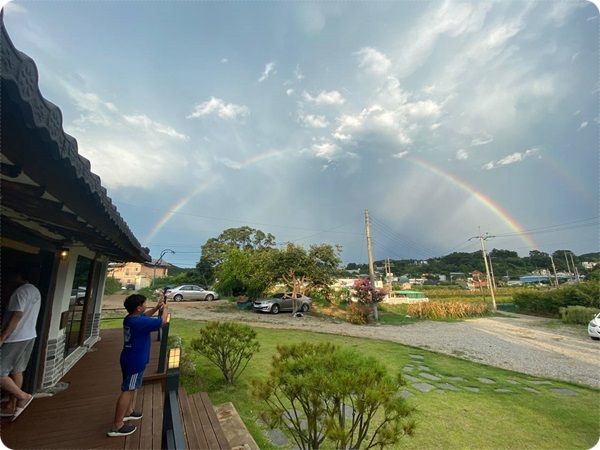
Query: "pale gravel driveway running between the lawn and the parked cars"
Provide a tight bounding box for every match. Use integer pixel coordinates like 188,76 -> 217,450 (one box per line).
106,297 -> 600,388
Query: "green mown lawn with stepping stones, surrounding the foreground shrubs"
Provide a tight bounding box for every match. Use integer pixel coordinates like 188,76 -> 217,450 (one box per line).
103,319 -> 600,449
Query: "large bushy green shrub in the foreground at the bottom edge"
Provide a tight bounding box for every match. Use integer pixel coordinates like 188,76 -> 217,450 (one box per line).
254,343 -> 414,450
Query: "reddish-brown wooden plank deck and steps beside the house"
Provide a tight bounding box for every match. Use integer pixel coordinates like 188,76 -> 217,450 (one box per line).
0,329 -> 229,450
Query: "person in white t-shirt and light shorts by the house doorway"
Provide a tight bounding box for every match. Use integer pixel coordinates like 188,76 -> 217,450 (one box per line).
0,271 -> 41,420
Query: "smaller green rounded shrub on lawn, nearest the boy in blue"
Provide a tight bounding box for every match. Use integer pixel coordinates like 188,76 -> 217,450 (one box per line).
192,322 -> 260,384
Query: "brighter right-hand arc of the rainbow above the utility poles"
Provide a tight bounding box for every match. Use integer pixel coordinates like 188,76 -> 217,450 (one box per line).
402,156 -> 539,250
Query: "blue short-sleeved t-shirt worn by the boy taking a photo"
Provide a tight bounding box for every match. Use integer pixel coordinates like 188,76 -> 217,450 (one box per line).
121,314 -> 162,375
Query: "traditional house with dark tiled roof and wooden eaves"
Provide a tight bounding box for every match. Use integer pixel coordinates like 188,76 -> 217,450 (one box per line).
0,8 -> 150,392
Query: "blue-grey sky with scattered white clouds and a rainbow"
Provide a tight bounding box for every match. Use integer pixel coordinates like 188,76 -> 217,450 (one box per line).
4,0 -> 600,267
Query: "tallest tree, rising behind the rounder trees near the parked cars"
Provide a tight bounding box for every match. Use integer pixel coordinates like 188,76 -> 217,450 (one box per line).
196,226 -> 275,283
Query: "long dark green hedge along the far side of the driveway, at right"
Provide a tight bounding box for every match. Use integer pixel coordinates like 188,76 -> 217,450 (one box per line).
513,281 -> 600,316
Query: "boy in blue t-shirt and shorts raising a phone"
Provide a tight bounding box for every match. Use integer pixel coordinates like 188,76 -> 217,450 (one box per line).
107,294 -> 168,437
